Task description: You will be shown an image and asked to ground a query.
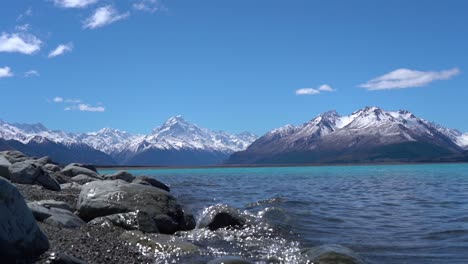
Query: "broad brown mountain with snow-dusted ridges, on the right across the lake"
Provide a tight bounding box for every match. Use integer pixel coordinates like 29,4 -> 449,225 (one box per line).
227,107 -> 468,164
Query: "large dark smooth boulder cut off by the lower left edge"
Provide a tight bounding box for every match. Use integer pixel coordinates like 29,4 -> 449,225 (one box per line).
0,178 -> 49,263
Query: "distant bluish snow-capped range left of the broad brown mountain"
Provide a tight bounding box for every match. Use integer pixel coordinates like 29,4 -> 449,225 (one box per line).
0,116 -> 257,166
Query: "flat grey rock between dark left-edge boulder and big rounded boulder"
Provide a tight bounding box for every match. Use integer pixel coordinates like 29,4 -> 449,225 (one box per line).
28,202 -> 86,228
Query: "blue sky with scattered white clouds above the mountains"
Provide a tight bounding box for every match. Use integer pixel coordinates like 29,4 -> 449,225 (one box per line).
0,0 -> 468,134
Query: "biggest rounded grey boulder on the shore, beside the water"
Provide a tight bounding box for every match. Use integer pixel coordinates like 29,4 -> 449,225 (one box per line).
77,180 -> 194,234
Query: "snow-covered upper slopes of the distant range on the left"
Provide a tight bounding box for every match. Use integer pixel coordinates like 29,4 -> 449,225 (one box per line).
0,116 -> 257,156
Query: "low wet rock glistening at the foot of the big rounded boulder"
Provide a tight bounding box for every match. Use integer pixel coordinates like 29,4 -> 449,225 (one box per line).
88,211 -> 159,233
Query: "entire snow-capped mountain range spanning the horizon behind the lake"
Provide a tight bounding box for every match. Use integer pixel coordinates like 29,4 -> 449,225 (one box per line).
0,107 -> 468,166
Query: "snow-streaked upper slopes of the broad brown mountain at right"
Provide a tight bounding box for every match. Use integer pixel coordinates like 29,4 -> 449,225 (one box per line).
247,106 -> 468,151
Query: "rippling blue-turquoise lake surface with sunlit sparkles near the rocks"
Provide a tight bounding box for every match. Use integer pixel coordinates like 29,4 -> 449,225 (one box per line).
101,164 -> 468,264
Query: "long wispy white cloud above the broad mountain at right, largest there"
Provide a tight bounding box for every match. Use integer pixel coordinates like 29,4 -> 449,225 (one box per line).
359,68 -> 460,91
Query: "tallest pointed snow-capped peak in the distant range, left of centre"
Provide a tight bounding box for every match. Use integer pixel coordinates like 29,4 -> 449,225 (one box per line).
119,116 -> 256,165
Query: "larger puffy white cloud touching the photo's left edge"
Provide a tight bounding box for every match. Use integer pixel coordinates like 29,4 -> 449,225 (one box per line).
0,33 -> 42,54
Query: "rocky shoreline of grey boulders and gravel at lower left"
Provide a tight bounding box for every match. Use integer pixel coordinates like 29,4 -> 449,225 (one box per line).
0,151 -> 364,264
